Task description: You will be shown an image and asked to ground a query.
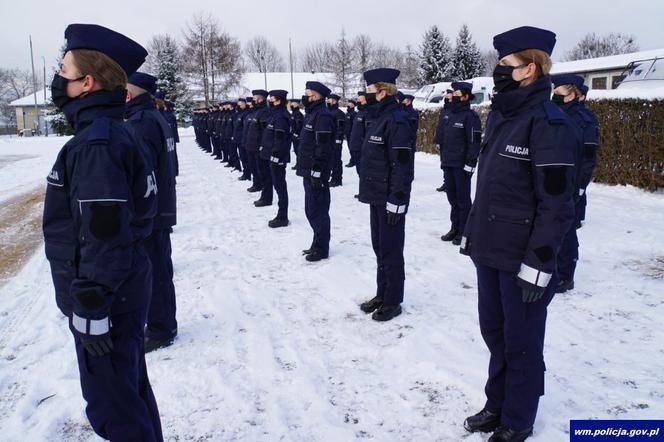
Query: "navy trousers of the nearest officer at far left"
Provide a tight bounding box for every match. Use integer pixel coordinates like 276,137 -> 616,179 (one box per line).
69,307 -> 164,442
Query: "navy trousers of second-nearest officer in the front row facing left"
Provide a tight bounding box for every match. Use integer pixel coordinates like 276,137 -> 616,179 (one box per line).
370,204 -> 406,305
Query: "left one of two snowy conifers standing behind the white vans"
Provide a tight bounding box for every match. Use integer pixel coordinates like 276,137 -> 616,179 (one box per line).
418,25 -> 454,84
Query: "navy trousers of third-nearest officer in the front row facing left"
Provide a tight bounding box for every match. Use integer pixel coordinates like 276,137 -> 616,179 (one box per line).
302,174 -> 330,254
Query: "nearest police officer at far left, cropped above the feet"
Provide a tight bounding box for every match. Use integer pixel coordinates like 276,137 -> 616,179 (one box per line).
43,24 -> 163,441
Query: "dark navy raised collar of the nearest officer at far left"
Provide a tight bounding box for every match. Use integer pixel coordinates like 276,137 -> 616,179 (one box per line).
63,89 -> 127,133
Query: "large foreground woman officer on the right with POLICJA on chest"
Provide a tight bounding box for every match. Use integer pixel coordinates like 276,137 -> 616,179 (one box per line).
461,26 -> 579,442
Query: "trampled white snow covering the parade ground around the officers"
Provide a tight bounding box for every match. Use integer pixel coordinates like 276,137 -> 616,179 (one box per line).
0,131 -> 664,442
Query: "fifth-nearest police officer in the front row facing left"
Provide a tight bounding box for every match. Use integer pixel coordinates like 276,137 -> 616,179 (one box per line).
244,89 -> 272,193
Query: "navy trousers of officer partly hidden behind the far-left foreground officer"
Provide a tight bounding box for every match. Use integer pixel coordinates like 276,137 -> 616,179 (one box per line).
145,229 -> 178,341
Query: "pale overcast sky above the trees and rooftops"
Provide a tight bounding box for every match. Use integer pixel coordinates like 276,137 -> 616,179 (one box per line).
0,0 -> 664,76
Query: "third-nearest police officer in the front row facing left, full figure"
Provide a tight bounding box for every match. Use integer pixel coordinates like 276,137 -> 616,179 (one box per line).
296,81 -> 336,262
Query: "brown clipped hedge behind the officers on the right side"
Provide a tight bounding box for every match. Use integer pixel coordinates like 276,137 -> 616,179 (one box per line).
417,99 -> 664,191
